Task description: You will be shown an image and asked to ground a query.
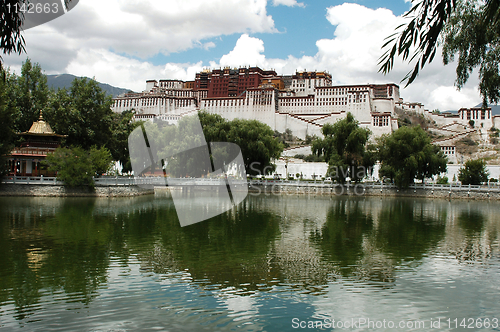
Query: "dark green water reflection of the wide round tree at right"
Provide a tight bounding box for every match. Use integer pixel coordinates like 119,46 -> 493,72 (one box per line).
375,199 -> 446,261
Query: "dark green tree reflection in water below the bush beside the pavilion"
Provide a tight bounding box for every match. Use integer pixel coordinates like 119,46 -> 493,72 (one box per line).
41,199 -> 113,304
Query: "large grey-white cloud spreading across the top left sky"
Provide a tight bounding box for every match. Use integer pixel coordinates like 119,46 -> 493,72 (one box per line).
1,0 -> 276,72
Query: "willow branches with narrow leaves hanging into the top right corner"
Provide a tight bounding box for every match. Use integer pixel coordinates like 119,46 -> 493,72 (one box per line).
379,0 -> 500,104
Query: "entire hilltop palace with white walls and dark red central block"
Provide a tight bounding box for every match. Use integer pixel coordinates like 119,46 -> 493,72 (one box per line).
112,67 -> 500,165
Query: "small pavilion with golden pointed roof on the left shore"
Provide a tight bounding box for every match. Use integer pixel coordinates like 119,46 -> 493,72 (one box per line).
7,111 -> 66,176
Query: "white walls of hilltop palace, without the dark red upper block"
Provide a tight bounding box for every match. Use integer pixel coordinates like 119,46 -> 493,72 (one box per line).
112,80 -> 399,139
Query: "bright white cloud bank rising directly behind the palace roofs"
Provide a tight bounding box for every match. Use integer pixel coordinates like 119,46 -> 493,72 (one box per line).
210,3 -> 481,111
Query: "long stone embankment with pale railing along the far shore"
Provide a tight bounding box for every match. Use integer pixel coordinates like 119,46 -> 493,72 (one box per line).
0,178 -> 500,200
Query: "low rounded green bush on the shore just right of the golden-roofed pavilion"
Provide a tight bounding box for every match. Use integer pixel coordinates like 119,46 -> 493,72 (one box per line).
44,147 -> 95,187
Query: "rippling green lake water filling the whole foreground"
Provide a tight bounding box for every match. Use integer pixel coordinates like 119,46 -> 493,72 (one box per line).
0,194 -> 500,331
